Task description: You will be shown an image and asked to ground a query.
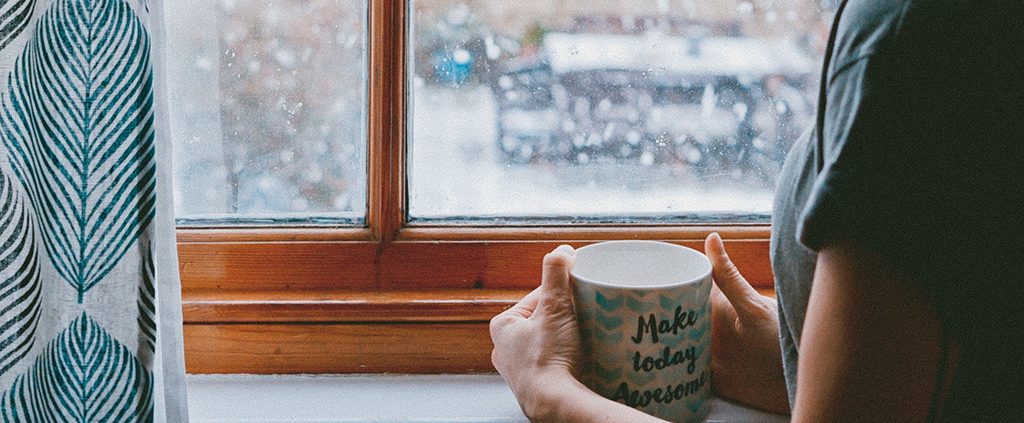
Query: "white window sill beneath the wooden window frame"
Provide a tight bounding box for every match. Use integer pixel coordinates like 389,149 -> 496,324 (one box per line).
186,375 -> 787,423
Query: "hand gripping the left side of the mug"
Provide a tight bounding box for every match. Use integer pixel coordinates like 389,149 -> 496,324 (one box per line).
490,245 -> 582,420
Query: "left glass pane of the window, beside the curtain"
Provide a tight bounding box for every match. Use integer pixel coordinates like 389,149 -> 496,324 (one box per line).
165,0 -> 368,223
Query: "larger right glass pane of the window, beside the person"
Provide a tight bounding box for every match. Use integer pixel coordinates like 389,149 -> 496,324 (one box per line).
409,0 -> 831,221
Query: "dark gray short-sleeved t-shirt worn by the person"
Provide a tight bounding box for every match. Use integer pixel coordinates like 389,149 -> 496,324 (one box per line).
771,0 -> 1024,421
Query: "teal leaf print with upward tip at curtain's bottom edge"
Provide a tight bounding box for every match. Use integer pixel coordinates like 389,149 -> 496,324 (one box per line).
0,313 -> 153,422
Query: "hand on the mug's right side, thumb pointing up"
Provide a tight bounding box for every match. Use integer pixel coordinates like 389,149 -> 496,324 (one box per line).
705,230 -> 790,414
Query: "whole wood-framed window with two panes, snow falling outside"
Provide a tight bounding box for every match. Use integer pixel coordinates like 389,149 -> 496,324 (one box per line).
165,0 -> 829,373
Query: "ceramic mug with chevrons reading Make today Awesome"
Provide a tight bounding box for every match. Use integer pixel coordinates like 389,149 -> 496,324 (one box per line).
571,241 -> 712,422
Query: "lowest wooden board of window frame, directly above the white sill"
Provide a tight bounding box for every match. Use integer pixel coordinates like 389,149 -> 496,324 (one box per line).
184,323 -> 494,374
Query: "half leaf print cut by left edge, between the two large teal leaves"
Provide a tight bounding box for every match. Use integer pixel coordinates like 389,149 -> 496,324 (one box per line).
0,171 -> 40,375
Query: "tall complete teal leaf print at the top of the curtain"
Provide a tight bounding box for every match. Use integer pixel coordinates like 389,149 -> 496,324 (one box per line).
0,0 -> 156,303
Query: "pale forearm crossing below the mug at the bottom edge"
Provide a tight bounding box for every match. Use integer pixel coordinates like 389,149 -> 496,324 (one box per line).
525,380 -> 665,423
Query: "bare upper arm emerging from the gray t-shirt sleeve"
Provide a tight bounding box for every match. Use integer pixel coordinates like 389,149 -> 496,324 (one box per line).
793,241 -> 941,422
